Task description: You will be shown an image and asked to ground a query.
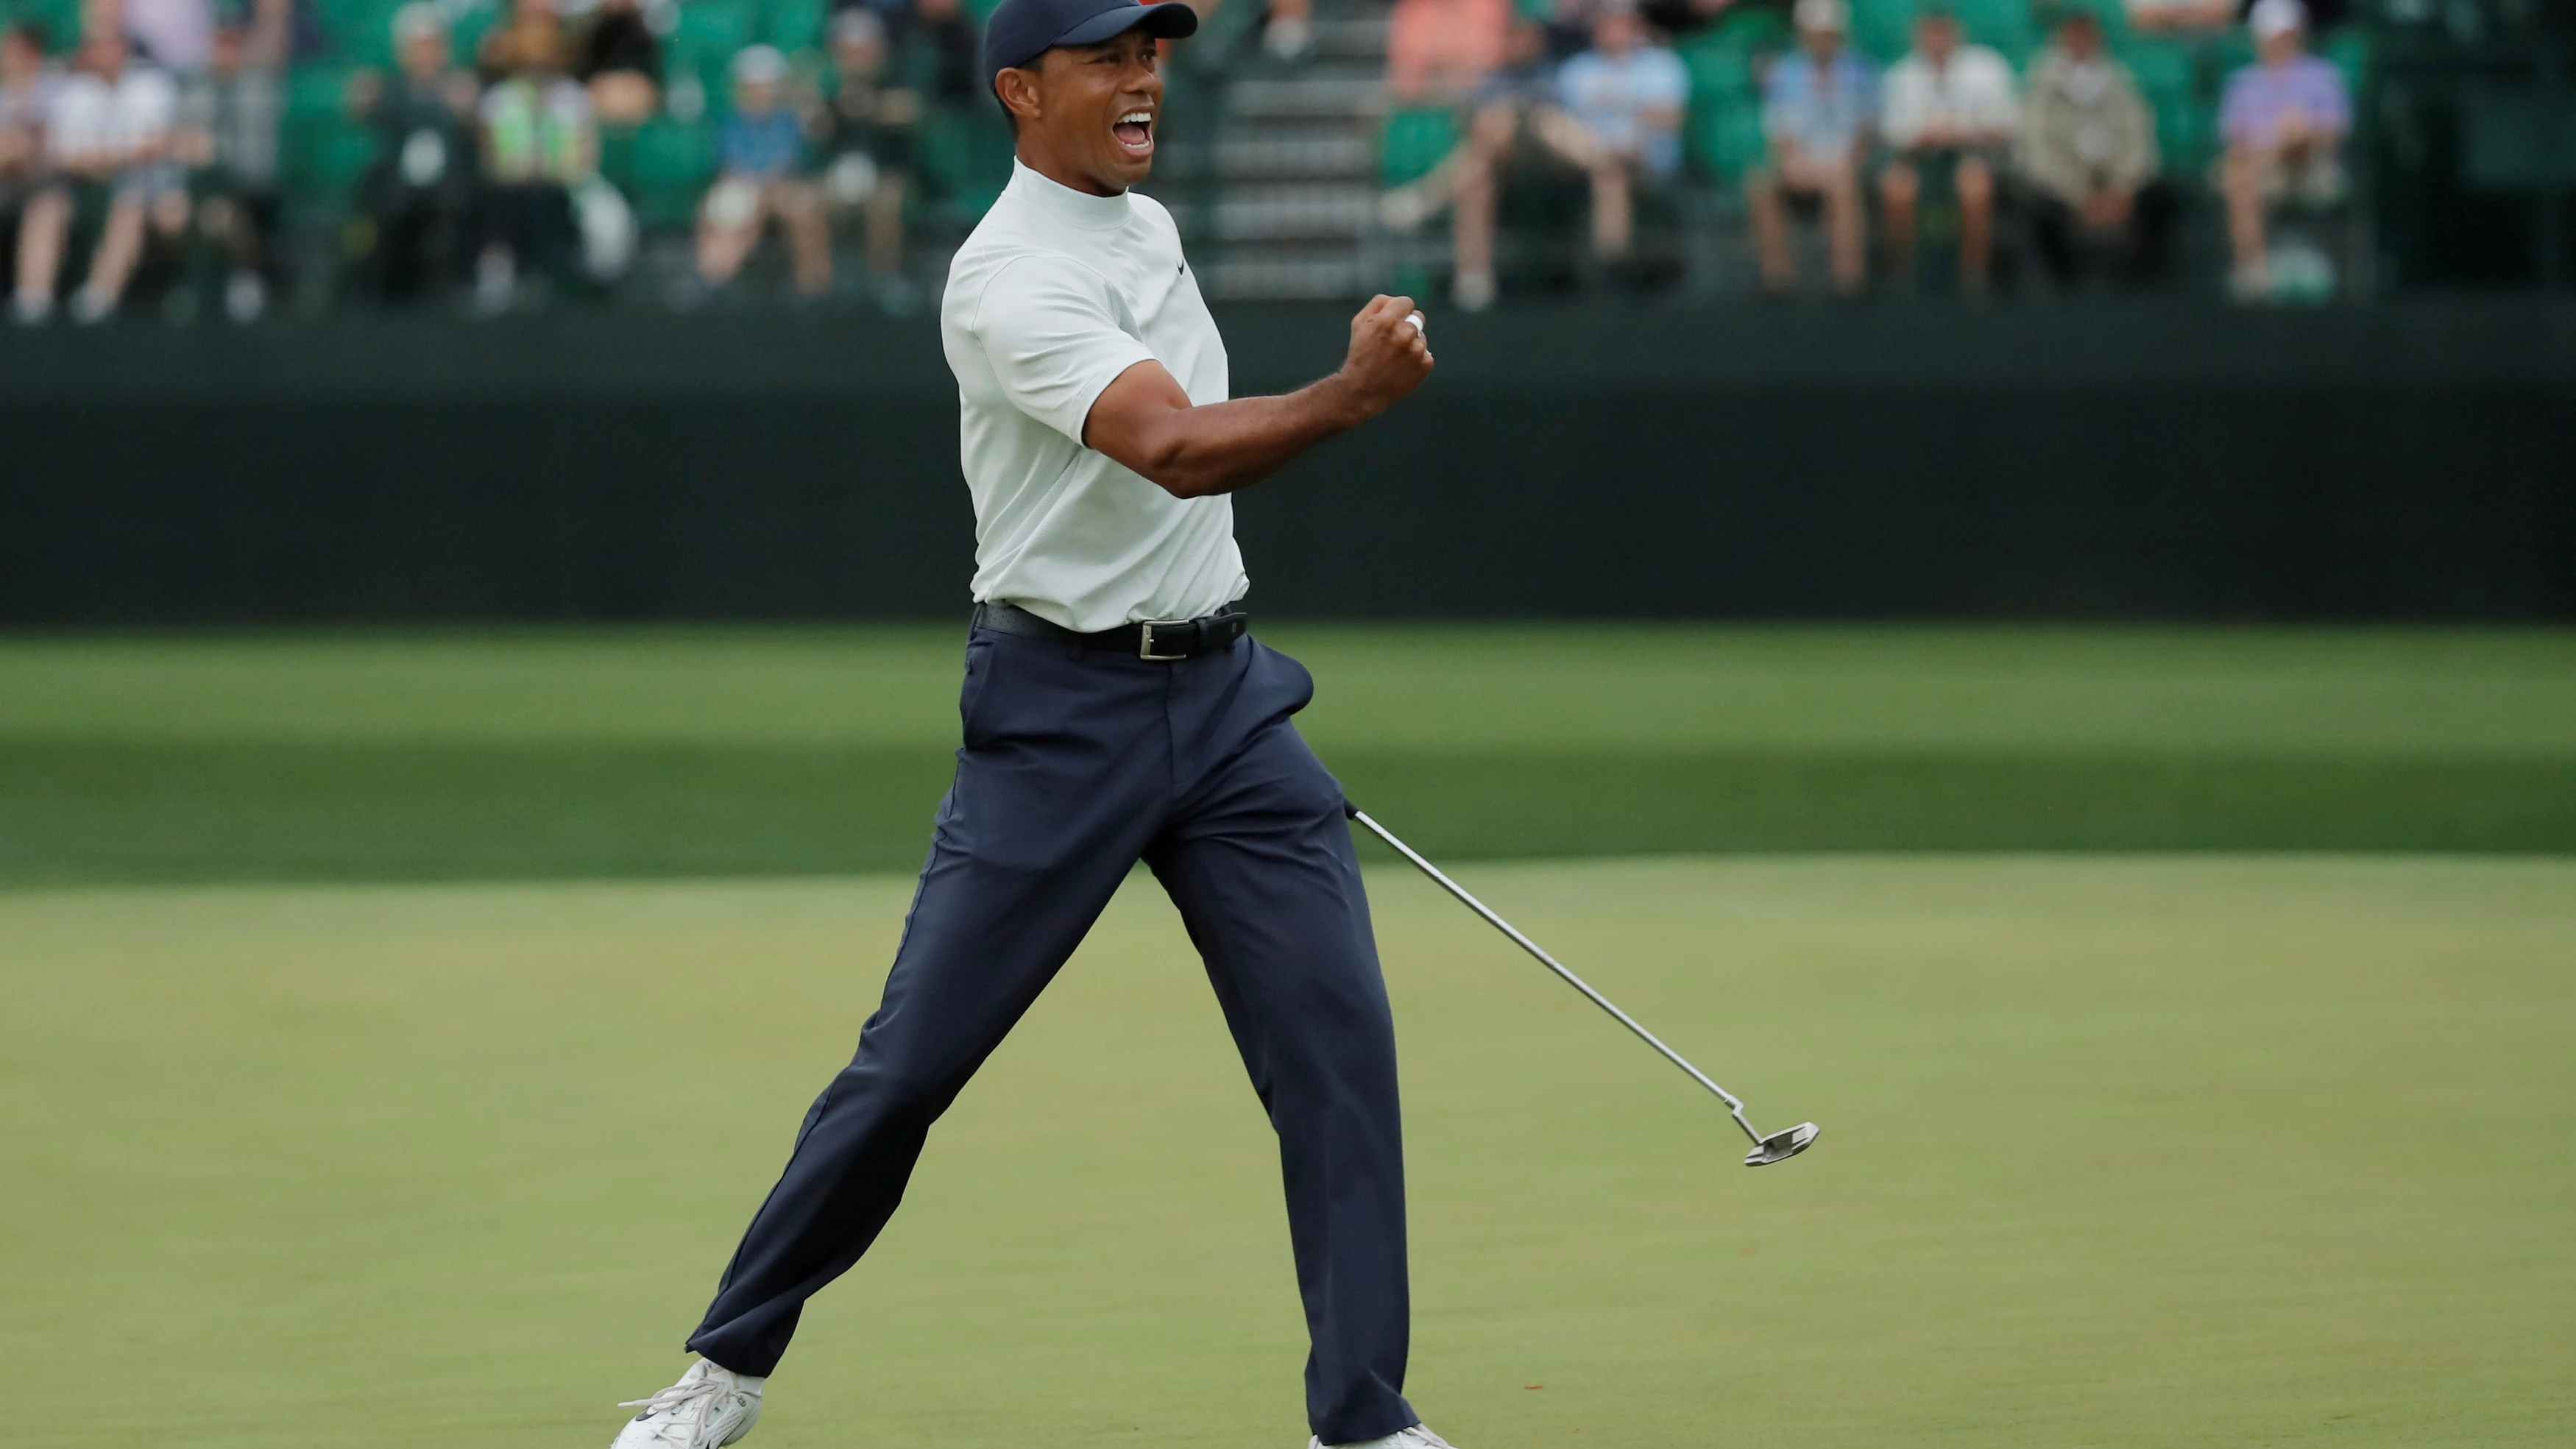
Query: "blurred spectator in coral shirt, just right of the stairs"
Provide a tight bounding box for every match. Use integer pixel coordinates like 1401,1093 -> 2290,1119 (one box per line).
1379,0 -> 1535,311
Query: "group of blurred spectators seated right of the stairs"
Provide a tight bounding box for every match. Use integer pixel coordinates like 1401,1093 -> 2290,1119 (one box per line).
1381,0 -> 2352,309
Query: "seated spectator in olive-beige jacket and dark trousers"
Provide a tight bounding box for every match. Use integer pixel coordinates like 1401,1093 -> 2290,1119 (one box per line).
2014,10 -> 2177,286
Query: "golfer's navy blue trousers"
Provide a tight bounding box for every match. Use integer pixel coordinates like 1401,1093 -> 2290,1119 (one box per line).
688,617 -> 1417,1444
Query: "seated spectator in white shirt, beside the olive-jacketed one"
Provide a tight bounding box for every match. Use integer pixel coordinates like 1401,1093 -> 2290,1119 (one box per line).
1878,0 -> 2023,294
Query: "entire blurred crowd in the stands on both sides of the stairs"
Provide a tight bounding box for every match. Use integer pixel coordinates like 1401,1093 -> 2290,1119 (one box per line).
0,0 -> 2352,325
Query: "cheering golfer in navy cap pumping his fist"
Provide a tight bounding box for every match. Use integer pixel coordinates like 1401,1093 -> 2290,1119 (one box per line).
616,0 -> 1443,1449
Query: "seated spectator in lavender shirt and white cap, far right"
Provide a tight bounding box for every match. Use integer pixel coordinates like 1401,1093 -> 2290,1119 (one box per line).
2218,0 -> 2352,301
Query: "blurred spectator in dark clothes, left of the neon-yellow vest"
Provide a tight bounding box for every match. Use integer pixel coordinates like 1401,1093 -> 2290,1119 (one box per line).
350,0 -> 479,301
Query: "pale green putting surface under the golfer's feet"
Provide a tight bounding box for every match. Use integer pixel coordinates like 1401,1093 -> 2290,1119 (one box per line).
0,857 -> 2576,1449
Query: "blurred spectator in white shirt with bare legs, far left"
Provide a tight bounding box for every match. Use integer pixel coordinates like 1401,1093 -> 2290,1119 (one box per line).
13,26 -> 188,322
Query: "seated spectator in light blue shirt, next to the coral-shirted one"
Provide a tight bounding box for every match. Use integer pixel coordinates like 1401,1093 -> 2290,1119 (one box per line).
1538,0 -> 1690,275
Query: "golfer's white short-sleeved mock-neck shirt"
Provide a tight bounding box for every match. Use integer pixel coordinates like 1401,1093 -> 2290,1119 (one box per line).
941,162 -> 1250,633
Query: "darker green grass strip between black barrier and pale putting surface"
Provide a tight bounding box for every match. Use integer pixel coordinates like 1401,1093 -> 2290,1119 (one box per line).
0,626 -> 2576,885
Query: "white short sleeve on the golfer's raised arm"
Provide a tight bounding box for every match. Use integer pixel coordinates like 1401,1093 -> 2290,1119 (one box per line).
972,252 -> 1154,443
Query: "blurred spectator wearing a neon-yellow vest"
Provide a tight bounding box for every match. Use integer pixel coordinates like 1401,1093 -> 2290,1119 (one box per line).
474,0 -> 598,316
